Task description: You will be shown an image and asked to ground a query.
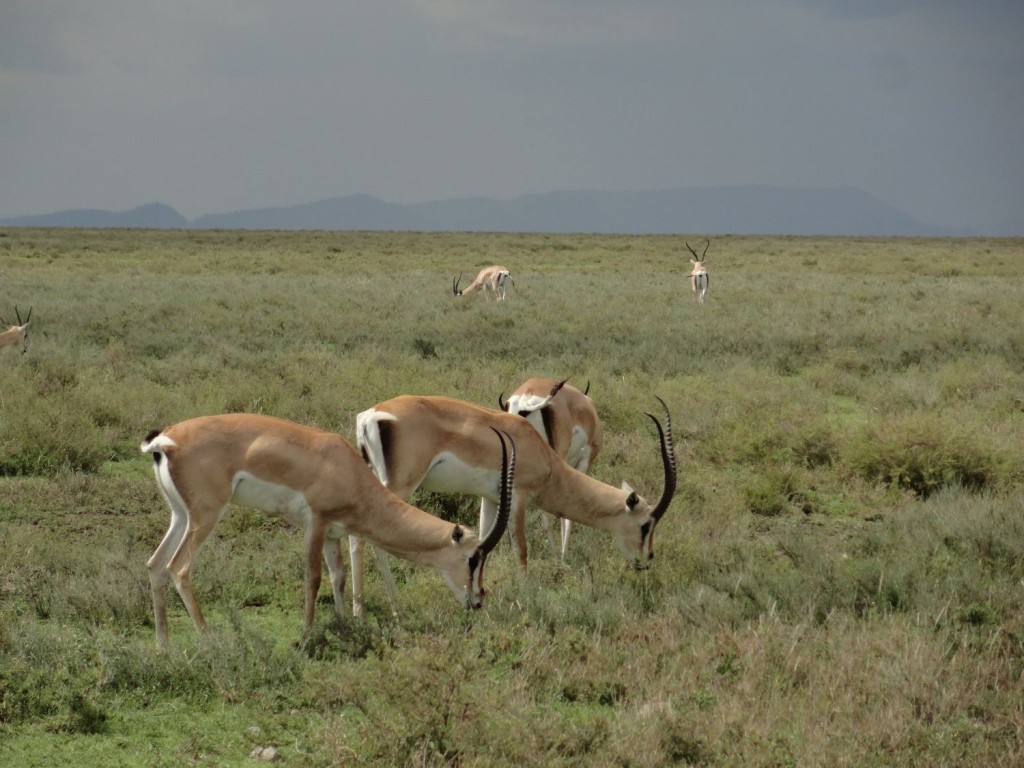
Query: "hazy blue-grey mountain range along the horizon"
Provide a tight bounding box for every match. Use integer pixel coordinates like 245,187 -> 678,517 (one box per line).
0,186 -> 974,237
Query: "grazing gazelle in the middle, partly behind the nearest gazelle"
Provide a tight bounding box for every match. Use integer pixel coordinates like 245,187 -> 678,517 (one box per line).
349,395 -> 676,618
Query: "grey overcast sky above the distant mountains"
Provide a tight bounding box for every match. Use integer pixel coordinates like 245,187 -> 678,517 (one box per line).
0,0 -> 1024,234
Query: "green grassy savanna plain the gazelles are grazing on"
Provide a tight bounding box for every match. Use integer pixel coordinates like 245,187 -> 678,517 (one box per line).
0,229 -> 1024,768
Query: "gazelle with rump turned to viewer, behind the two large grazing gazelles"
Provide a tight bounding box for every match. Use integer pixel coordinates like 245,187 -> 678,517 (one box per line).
498,378 -> 603,560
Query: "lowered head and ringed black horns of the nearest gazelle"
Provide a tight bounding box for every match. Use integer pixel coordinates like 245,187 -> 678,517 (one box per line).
441,427 -> 515,609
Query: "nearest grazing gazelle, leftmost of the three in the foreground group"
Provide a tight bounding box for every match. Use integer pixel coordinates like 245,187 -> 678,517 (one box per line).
140,414 -> 515,647
